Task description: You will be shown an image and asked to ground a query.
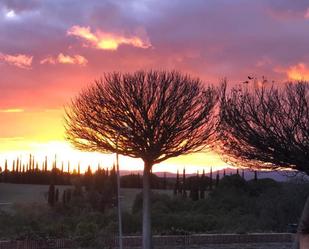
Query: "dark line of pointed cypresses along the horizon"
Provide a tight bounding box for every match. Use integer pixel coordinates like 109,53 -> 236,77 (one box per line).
0,155 -> 257,198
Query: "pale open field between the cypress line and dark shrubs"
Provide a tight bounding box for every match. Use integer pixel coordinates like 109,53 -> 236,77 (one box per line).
0,183 -> 173,211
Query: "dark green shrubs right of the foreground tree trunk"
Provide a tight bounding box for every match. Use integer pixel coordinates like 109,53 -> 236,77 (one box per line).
131,175 -> 309,233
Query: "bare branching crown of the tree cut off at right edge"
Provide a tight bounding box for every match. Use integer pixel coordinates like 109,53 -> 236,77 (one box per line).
218,82 -> 309,174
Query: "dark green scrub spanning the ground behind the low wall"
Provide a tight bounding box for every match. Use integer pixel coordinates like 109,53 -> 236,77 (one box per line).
0,175 -> 309,249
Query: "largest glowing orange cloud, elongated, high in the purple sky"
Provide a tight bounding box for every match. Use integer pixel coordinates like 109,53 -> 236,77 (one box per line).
67,25 -> 151,50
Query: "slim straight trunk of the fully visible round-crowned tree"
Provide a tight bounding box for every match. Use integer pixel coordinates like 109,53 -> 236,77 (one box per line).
143,162 -> 153,249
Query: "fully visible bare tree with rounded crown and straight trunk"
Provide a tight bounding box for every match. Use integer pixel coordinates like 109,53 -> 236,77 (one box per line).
66,71 -> 218,249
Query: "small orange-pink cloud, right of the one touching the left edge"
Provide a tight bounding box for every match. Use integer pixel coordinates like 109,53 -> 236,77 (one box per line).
40,53 -> 88,66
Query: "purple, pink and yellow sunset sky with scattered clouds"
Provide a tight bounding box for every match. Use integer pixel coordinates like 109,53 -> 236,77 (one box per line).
0,0 -> 309,172
